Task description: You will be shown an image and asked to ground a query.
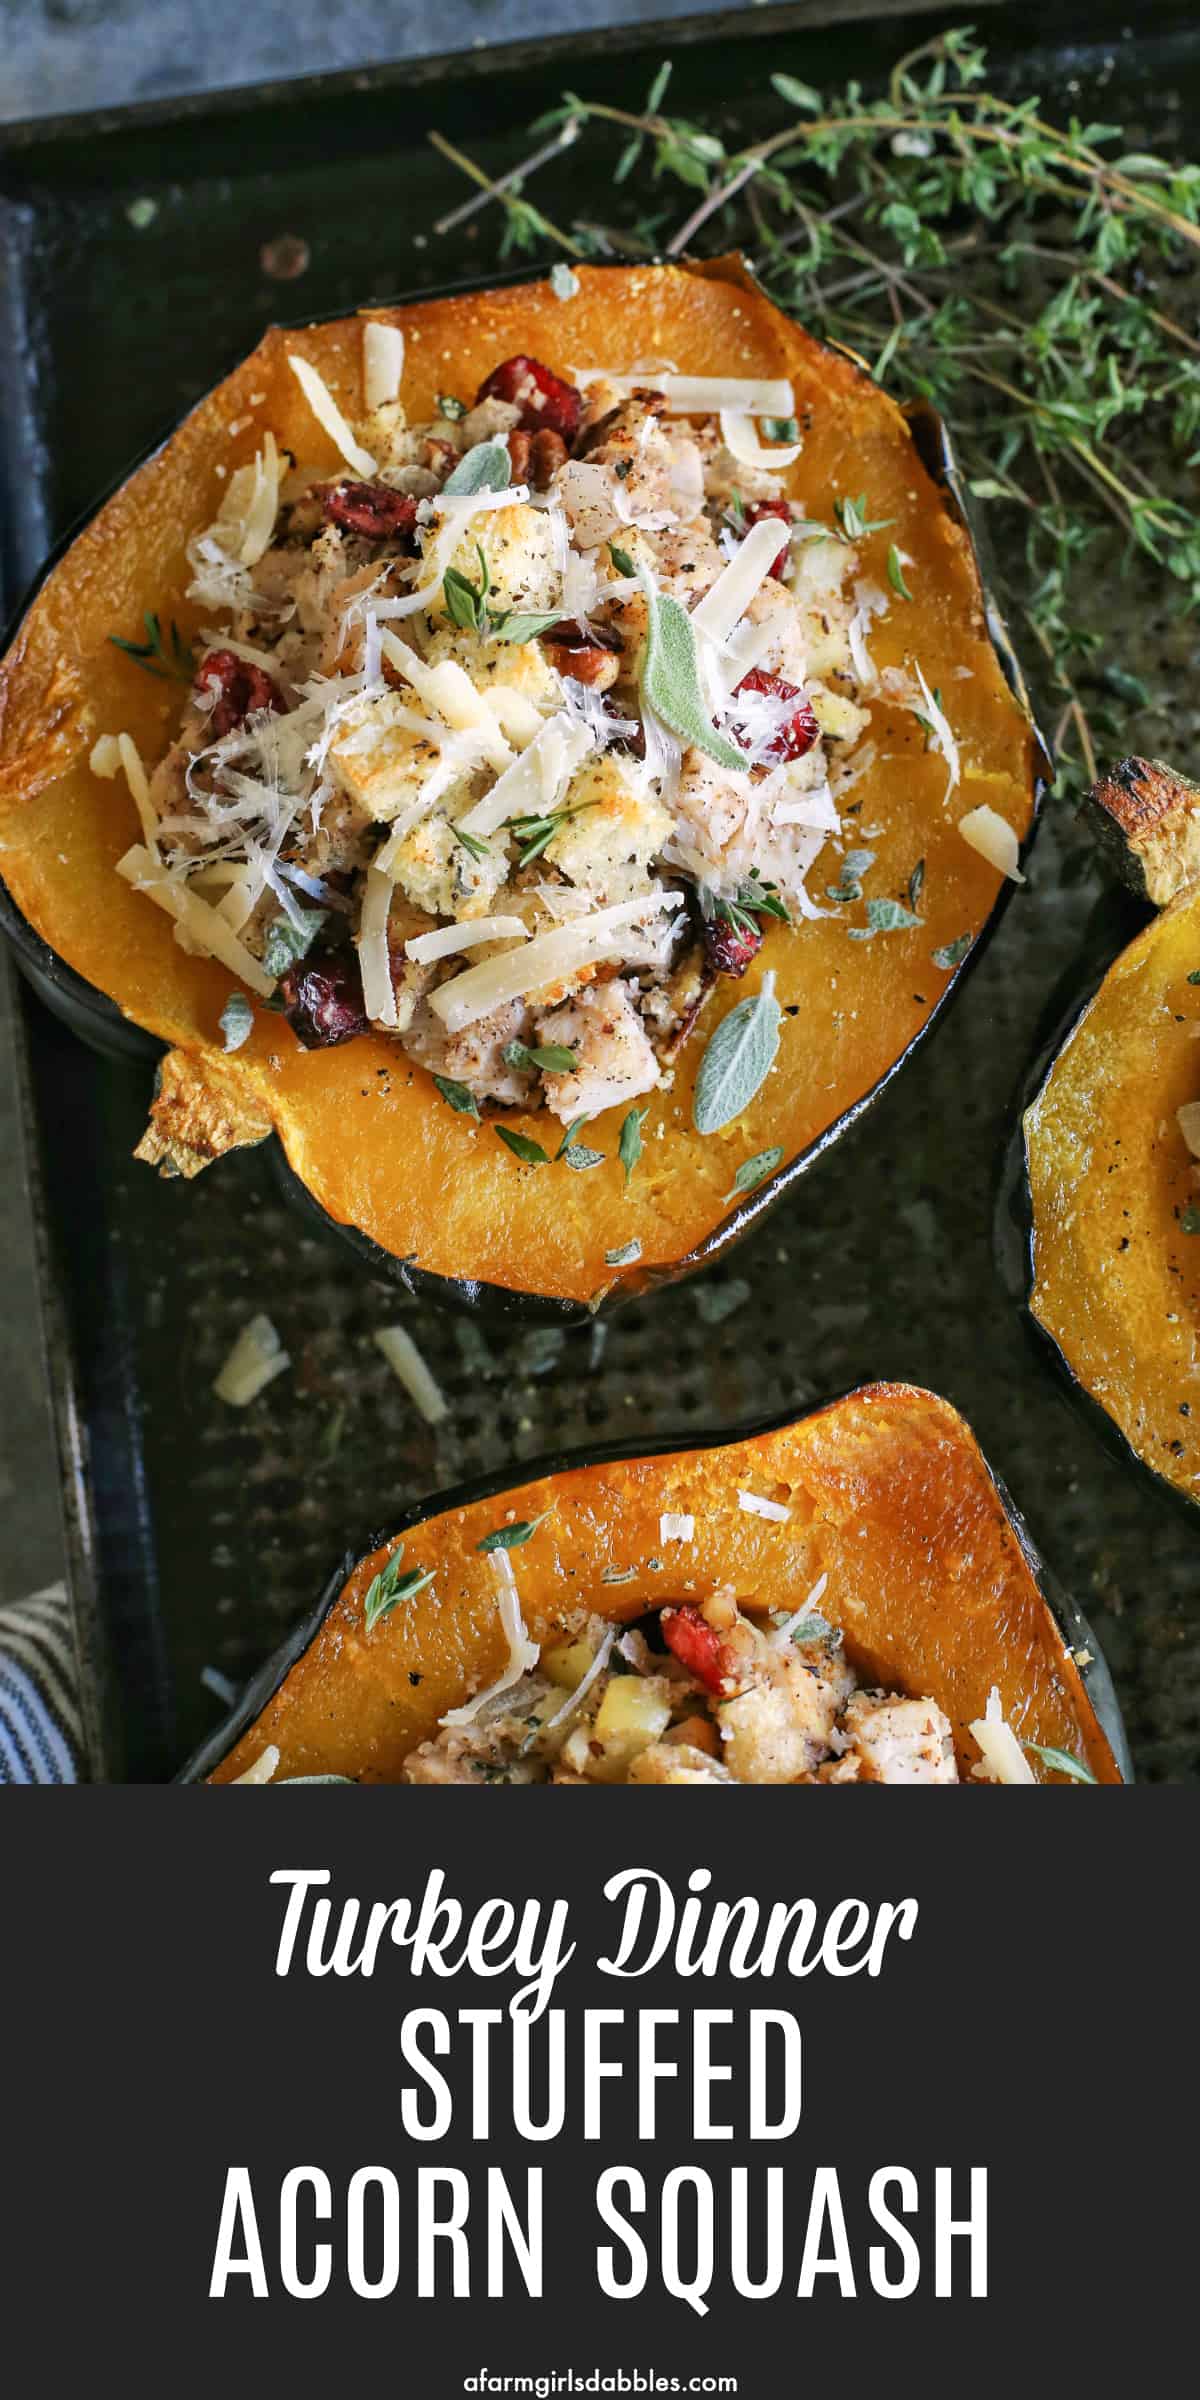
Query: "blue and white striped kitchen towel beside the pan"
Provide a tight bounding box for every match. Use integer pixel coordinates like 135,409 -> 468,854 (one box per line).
0,1584 -> 84,1783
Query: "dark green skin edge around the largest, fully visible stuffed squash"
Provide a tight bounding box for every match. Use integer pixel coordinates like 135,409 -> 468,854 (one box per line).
0,338 -> 1051,1327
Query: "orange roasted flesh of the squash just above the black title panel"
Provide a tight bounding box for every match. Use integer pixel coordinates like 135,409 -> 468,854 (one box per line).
211,1385 -> 1121,1783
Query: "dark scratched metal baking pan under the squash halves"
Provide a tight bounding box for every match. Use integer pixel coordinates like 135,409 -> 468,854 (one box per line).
0,0 -> 1200,1781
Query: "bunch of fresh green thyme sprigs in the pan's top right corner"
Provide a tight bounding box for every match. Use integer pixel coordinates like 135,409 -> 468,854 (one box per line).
432,26 -> 1200,787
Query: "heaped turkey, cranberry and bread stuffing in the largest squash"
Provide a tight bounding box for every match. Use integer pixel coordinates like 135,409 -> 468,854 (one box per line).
112,322 -> 888,1123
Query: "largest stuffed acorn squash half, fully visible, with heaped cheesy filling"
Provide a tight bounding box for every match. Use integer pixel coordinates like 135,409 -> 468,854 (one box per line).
0,262 -> 1042,1313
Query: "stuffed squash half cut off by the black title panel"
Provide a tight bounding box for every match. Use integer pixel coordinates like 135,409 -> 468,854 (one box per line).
187,1385 -> 1126,1783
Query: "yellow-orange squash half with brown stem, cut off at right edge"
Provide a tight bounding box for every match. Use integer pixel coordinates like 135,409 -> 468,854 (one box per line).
1025,758 -> 1200,1500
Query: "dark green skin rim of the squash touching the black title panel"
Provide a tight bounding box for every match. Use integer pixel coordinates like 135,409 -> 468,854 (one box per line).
175,1392 -> 1133,1783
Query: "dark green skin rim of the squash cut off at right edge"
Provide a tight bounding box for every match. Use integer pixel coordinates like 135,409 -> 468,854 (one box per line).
994,878 -> 1200,1526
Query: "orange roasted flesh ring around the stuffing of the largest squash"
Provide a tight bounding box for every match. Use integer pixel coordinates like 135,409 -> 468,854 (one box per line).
0,262 -> 1037,1303
